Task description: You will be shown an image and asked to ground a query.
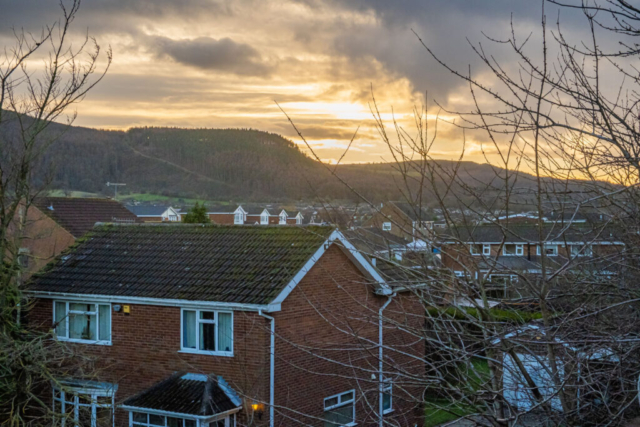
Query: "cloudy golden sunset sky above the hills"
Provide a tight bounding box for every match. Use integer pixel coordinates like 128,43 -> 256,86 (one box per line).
0,0 -> 592,162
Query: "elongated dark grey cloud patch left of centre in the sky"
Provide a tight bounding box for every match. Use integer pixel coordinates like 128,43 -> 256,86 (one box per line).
150,36 -> 272,76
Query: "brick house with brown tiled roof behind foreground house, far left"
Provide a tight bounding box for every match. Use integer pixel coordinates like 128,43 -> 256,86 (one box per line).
12,197 -> 140,275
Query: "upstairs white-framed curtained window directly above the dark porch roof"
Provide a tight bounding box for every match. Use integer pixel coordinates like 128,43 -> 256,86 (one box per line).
181,310 -> 233,356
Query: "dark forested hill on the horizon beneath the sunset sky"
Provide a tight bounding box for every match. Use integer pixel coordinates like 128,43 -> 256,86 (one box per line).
0,115 -> 596,202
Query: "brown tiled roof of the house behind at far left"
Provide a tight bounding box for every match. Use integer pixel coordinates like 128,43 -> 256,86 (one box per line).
33,197 -> 139,237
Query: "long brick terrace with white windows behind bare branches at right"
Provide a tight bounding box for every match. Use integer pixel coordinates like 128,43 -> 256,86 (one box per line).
437,222 -> 625,298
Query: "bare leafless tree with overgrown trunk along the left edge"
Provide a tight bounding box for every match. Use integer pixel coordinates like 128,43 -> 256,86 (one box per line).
0,0 -> 112,426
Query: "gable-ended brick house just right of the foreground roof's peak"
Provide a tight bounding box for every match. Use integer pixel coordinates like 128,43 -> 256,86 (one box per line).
362,202 -> 434,242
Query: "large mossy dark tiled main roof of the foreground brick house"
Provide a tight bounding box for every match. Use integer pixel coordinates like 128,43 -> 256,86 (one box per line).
31,224 -> 334,304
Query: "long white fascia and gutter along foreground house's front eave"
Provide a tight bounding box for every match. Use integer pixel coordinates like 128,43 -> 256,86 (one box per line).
26,291 -> 280,313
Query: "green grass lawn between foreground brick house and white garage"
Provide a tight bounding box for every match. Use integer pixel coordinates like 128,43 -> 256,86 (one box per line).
424,359 -> 490,427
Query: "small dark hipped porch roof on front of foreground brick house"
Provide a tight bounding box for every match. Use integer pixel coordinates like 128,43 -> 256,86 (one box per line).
123,372 -> 241,417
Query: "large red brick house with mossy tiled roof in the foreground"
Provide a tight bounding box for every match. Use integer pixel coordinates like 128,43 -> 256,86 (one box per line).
29,224 -> 424,427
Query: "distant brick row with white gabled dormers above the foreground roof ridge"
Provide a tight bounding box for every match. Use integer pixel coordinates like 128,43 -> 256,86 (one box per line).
207,205 -> 304,225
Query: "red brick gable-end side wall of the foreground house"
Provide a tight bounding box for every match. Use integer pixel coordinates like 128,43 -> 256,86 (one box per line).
274,246 -> 424,426
